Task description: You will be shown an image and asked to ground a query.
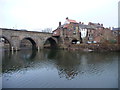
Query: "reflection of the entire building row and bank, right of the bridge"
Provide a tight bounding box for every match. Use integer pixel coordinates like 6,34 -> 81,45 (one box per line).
48,51 -> 118,80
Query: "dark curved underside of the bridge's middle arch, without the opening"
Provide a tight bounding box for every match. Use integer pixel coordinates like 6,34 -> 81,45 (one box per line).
20,37 -> 37,49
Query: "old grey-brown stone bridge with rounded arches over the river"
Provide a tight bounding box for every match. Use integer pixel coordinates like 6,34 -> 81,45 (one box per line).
0,28 -> 57,50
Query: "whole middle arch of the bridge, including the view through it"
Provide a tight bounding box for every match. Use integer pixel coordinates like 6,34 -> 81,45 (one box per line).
20,37 -> 37,49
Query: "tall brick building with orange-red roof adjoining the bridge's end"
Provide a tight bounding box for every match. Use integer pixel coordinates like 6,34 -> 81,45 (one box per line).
53,18 -> 80,45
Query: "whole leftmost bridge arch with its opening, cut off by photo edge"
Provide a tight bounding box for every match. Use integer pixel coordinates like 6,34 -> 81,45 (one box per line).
0,36 -> 11,50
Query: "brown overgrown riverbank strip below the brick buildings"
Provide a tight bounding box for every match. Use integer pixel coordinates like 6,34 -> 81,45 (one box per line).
60,44 -> 120,51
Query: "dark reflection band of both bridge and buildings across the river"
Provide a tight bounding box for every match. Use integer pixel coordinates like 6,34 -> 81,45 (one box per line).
2,50 -> 118,80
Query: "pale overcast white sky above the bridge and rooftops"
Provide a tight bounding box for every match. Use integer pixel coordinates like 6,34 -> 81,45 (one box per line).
0,0 -> 120,31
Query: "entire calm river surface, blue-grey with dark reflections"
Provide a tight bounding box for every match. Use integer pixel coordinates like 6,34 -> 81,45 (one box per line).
2,49 -> 118,88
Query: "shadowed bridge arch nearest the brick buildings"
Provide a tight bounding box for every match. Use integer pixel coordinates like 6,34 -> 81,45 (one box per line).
44,37 -> 58,48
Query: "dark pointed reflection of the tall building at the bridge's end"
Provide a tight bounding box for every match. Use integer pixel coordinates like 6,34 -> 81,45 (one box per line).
50,51 -> 80,80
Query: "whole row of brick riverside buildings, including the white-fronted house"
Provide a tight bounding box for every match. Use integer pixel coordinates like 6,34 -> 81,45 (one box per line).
52,18 -> 113,45
